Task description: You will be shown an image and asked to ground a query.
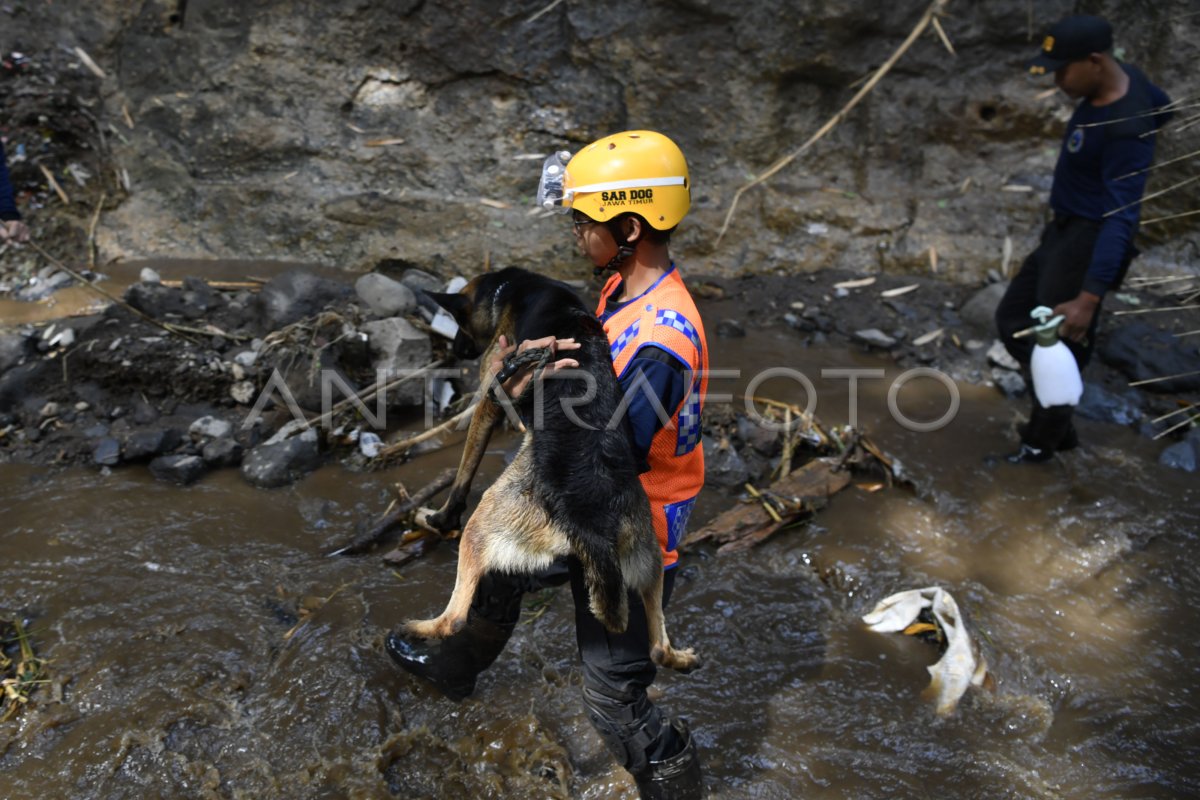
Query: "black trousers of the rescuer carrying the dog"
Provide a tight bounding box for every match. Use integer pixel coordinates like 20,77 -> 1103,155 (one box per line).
470,558 -> 685,775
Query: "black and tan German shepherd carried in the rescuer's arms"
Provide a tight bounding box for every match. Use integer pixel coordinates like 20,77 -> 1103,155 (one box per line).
406,267 -> 700,672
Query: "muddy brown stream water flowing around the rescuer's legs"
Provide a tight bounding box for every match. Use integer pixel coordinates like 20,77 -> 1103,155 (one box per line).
0,284 -> 1200,799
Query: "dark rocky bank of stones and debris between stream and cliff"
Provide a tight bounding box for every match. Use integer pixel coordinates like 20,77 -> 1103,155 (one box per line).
0,270 -> 1200,488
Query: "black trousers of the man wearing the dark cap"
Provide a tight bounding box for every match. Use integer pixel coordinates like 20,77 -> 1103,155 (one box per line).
996,217 -> 1136,450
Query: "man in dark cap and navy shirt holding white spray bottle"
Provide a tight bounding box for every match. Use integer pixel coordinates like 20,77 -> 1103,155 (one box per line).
996,16 -> 1170,463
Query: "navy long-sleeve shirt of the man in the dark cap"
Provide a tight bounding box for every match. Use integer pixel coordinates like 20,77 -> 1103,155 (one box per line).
1050,65 -> 1170,296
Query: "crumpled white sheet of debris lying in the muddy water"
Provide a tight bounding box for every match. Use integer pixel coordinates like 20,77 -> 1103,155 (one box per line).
863,587 -> 988,716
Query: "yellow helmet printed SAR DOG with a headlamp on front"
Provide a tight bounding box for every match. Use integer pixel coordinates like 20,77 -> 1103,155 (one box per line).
538,131 -> 691,230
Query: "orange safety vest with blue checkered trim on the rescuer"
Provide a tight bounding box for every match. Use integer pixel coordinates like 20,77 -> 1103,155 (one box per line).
596,266 -> 708,567
